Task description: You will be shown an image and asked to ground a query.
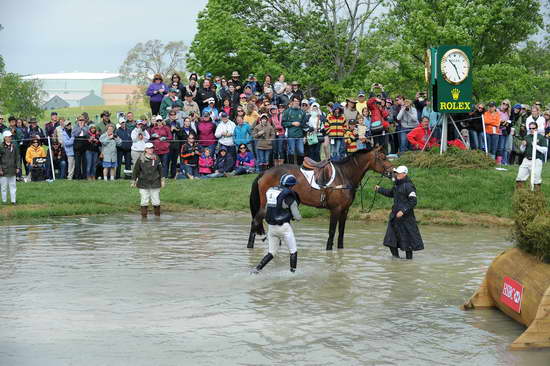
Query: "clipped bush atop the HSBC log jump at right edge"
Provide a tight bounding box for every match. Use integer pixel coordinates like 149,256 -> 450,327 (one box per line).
512,189 -> 550,263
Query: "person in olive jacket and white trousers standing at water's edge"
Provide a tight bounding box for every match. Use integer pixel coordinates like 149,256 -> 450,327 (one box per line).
132,142 -> 164,218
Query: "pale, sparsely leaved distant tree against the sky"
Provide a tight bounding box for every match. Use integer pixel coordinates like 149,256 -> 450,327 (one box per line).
119,40 -> 187,85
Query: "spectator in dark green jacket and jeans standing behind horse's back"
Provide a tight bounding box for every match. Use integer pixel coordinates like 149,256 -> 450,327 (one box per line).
282,96 -> 307,165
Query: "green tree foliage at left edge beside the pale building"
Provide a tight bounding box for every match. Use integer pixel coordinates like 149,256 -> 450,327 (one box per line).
0,73 -> 43,118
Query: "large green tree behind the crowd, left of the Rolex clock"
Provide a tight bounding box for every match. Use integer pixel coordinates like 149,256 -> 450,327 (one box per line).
188,0 -> 382,99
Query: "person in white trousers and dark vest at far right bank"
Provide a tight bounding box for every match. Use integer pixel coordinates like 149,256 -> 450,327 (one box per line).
516,122 -> 548,191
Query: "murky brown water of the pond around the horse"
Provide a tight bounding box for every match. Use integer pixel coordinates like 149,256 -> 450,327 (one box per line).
0,212 -> 550,366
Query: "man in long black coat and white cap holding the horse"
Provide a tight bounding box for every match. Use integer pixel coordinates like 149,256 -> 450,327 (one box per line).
374,165 -> 424,259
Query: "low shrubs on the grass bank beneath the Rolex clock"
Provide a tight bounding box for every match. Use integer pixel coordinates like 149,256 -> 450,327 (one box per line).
396,147 -> 495,169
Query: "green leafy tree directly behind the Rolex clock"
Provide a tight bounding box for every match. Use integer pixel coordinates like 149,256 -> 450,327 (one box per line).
378,0 -> 543,98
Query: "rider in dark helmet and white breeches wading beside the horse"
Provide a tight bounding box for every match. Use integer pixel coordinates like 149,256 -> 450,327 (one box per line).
252,174 -> 302,273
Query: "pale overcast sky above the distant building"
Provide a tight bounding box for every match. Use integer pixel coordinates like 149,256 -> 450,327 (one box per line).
0,0 -> 207,74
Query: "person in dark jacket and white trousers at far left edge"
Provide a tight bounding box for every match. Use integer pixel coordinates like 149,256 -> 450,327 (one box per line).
0,130 -> 20,205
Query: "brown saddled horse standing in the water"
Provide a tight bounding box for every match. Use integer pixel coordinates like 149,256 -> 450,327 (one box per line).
247,146 -> 393,250
